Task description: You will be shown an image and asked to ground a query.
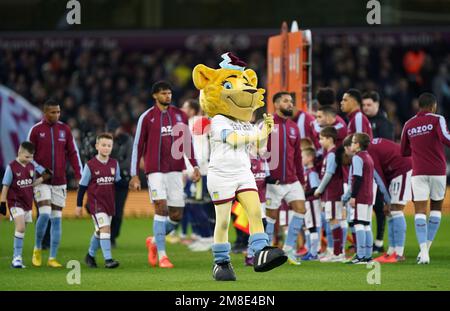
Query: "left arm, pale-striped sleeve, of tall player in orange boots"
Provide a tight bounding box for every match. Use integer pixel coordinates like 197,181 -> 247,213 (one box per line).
130,114 -> 148,190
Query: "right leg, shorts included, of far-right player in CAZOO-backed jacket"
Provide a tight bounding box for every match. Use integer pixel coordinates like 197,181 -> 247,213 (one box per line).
427,176 -> 447,254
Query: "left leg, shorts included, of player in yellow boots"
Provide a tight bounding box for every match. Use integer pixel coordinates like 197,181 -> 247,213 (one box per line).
32,184 -> 52,267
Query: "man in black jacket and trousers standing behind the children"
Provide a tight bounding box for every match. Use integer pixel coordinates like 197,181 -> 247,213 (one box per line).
362,91 -> 394,253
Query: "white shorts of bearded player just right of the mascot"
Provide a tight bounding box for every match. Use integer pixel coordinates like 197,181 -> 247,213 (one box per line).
266,181 -> 305,209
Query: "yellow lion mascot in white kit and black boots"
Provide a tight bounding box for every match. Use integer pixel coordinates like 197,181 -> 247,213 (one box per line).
192,53 -> 287,281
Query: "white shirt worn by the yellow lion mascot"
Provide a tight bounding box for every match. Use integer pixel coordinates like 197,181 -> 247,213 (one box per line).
208,115 -> 258,176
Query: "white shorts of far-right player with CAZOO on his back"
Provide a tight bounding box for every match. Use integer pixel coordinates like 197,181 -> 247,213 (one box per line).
411,175 -> 447,201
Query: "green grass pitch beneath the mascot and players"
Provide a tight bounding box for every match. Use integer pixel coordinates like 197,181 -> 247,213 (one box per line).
0,216 -> 450,291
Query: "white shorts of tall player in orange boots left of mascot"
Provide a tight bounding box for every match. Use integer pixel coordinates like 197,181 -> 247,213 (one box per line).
147,172 -> 184,207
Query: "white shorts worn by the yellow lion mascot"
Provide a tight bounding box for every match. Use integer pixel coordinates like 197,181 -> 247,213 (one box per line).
207,170 -> 258,205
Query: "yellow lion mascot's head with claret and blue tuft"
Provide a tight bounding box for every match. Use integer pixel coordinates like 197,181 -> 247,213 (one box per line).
192,53 -> 265,121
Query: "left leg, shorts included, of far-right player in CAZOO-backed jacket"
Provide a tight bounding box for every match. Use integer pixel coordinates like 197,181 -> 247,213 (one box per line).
411,175 -> 431,264
